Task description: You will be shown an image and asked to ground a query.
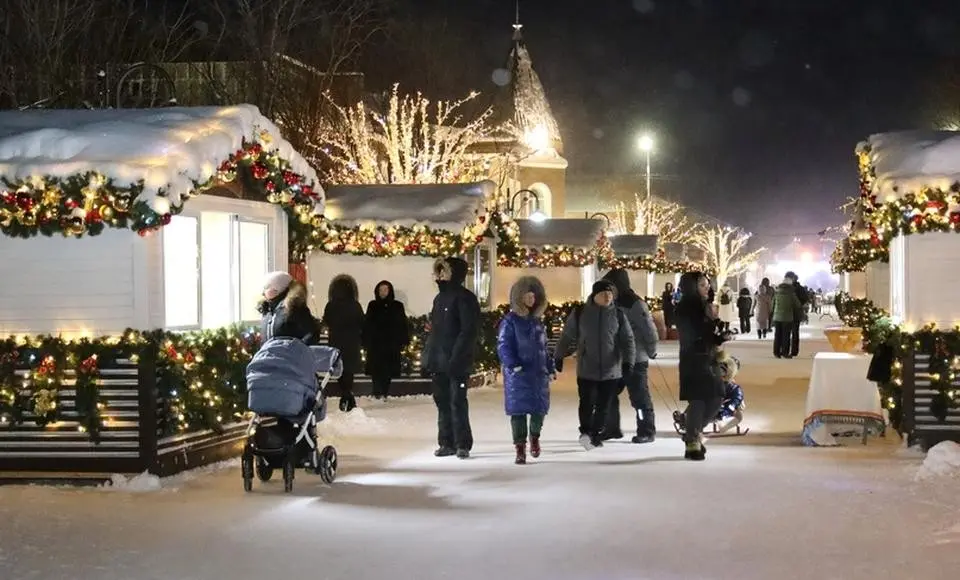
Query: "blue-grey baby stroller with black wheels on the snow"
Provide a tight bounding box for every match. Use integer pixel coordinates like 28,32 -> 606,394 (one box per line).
240,338 -> 343,492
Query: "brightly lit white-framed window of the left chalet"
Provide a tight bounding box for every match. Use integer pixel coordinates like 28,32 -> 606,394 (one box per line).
163,211 -> 272,329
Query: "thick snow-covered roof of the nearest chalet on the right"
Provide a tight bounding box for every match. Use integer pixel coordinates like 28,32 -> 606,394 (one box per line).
857,131 -> 960,196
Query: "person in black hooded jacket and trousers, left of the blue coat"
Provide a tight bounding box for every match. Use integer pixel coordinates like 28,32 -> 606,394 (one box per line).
420,258 -> 480,459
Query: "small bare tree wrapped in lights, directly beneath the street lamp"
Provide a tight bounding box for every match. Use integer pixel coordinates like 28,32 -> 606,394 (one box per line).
615,194 -> 701,244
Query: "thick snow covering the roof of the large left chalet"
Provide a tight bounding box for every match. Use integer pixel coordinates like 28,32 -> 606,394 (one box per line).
0,105 -> 323,209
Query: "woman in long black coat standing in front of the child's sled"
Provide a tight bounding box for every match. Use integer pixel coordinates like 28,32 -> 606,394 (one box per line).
676,272 -> 732,461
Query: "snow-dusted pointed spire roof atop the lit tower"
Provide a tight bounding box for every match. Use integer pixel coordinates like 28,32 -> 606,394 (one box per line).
493,21 -> 563,151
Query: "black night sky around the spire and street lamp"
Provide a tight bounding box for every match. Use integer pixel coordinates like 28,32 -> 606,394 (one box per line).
371,0 -> 960,247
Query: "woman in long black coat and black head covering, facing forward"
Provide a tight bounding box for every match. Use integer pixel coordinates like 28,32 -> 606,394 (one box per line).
363,280 -> 410,399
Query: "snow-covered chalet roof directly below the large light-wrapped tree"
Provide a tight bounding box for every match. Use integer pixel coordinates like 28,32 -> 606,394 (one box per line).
325,181 -> 496,232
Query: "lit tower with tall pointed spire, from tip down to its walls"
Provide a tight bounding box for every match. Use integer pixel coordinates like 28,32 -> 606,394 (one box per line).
494,9 -> 568,218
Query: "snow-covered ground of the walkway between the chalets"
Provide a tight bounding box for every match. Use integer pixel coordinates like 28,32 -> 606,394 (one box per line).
0,322 -> 960,580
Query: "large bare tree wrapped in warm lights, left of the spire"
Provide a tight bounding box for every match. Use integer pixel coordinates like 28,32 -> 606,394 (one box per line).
314,85 -> 492,183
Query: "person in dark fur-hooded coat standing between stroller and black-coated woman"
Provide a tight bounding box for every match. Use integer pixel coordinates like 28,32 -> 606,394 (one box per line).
323,274 -> 363,411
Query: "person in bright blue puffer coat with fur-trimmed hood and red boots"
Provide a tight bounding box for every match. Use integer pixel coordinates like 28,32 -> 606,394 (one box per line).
497,276 -> 556,465
